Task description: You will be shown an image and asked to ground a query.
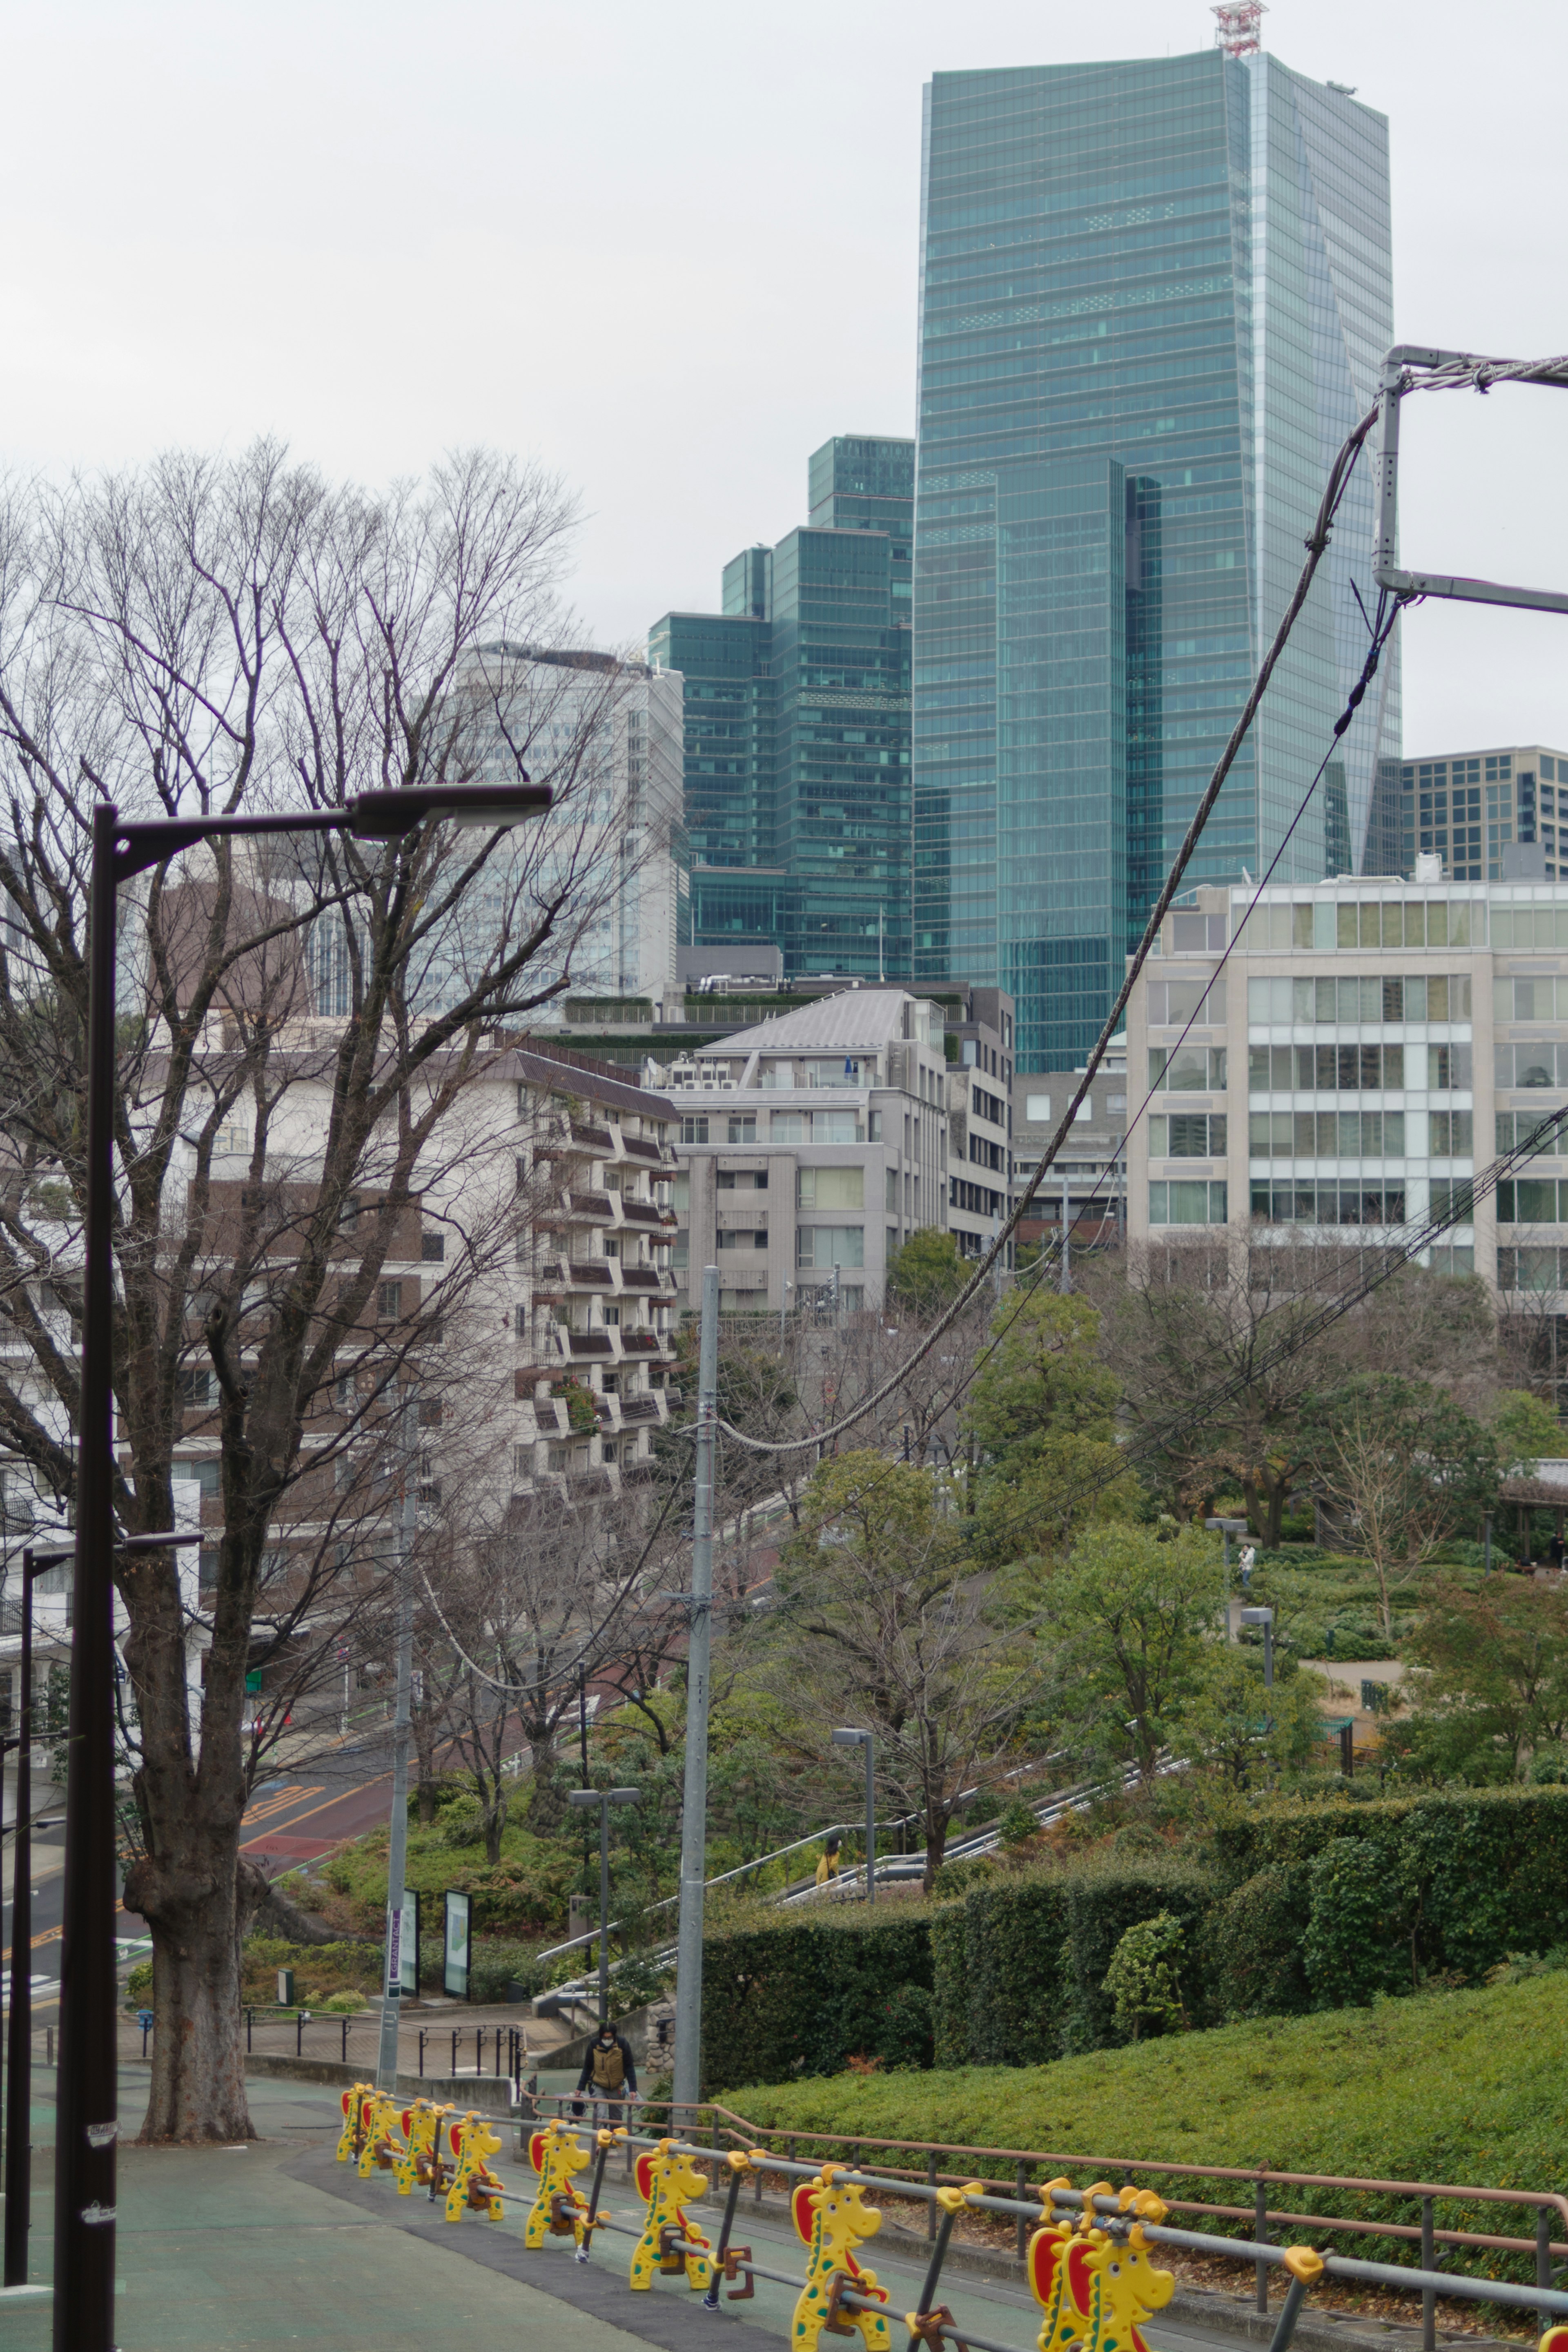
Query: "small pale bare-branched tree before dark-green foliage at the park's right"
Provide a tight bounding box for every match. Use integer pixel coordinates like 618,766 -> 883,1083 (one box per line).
1305,1371 -> 1497,1635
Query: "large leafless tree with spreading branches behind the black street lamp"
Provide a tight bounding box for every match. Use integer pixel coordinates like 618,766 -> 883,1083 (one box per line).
0,444 -> 648,2140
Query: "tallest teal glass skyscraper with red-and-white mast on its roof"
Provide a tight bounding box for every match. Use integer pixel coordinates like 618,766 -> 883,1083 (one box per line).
912,49 -> 1399,1070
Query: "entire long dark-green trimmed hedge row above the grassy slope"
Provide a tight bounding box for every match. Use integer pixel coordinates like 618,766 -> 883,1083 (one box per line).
705,1788 -> 1568,2089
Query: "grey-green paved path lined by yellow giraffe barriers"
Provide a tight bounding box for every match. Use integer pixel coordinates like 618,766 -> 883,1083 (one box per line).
0,2067 -> 1236,2352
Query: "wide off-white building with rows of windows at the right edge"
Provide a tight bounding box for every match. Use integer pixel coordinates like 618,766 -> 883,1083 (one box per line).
1128,875 -> 1568,1296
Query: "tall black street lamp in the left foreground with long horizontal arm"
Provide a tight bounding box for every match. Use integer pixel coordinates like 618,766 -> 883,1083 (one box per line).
54,776 -> 550,2352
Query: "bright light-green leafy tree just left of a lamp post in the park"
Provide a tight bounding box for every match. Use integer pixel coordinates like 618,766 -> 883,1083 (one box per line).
1034,1524 -> 1225,1788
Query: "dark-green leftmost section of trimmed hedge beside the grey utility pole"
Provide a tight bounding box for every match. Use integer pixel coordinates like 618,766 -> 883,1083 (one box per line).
703,1903 -> 931,2091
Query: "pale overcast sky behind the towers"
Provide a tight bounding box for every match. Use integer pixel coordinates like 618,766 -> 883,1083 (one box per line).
0,0 -> 1568,753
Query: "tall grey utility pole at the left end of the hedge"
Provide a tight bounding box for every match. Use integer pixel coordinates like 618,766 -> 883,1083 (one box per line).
670,1265 -> 724,2131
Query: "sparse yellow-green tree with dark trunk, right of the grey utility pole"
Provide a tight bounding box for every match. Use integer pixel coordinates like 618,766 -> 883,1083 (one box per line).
766,1449 -> 1030,1893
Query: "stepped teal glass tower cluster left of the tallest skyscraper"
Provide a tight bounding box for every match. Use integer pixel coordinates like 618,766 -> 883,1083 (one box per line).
649,435 -> 915,981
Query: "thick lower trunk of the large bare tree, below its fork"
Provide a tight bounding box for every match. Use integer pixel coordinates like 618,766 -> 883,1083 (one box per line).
125,1835 -> 266,2145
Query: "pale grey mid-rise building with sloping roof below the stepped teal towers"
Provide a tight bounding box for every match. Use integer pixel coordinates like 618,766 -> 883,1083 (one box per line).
649,988 -> 950,1315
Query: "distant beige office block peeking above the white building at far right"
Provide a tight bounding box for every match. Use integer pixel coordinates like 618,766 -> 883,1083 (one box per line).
1387,743 -> 1568,882
